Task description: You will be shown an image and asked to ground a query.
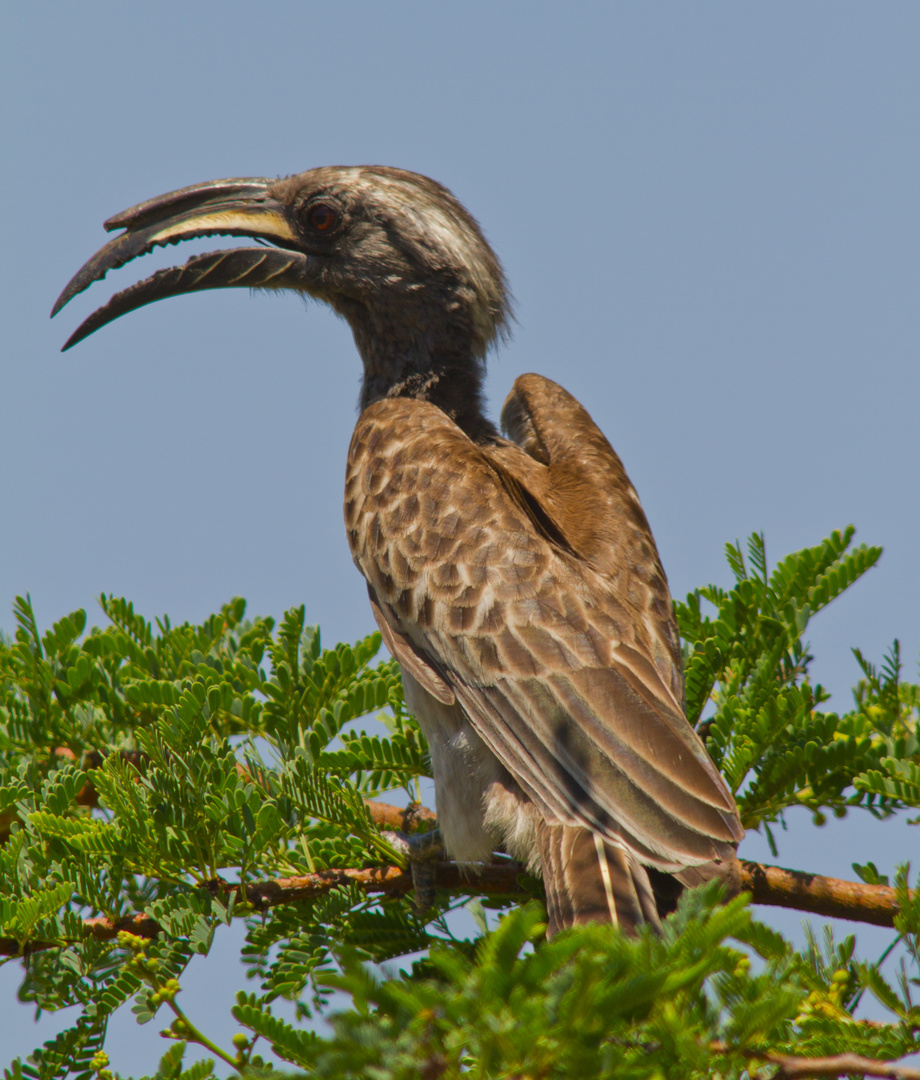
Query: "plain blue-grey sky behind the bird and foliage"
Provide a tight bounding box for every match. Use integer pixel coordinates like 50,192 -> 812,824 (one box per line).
0,0 -> 920,1075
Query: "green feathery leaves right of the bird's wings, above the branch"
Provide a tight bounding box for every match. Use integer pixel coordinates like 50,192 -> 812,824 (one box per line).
675,527 -> 920,843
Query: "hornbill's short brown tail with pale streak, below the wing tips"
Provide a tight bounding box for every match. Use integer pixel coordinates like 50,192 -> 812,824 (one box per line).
537,823 -> 661,937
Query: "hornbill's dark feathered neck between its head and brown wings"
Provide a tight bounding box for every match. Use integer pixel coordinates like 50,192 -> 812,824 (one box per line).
349,302 -> 499,443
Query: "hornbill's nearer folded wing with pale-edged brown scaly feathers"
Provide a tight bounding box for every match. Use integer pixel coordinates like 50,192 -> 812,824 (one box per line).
346,377 -> 741,870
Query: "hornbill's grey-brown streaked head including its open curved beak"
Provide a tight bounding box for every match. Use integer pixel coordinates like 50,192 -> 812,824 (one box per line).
52,165 -> 510,419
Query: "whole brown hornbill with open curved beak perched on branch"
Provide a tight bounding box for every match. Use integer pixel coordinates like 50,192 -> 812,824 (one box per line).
52,166 -> 743,934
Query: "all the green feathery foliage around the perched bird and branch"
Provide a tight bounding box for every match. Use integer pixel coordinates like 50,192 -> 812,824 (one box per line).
0,529 -> 920,1080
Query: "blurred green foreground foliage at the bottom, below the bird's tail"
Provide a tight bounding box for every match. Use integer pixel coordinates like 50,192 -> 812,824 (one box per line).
234,888 -> 917,1080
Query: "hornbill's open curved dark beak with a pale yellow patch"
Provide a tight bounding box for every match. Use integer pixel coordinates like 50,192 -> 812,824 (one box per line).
51,177 -> 314,352
